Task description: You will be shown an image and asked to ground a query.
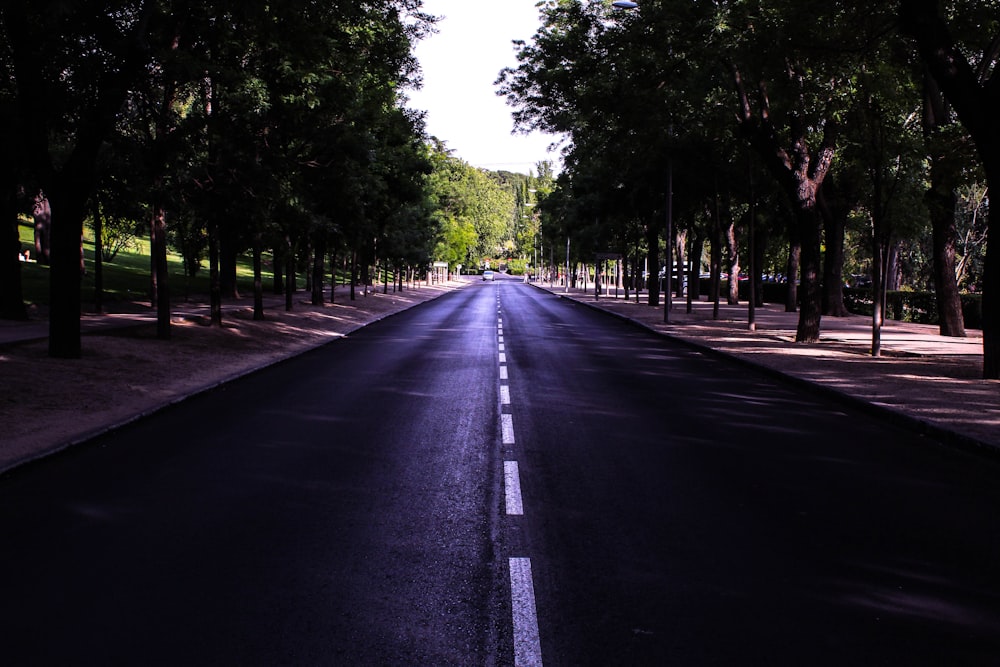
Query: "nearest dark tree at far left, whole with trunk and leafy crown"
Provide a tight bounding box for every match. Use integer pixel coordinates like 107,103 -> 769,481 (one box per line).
0,0 -> 158,358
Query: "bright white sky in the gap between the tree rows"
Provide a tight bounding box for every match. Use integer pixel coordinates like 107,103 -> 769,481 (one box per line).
407,0 -> 560,174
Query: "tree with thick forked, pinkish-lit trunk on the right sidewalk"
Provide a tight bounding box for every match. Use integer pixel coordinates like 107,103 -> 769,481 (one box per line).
724,0 -> 892,342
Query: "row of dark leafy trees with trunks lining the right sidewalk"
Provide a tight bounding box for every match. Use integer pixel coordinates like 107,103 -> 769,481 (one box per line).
497,0 -> 1000,378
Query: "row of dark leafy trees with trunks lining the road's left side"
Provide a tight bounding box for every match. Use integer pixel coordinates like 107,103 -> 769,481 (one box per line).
0,0 -> 437,357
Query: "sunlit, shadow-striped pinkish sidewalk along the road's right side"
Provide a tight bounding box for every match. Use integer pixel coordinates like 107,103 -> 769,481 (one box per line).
536,284 -> 1000,454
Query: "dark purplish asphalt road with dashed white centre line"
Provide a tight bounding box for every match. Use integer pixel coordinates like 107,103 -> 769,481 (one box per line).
0,280 -> 1000,665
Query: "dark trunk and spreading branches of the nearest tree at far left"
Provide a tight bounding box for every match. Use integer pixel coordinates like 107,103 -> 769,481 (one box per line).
4,2 -> 151,358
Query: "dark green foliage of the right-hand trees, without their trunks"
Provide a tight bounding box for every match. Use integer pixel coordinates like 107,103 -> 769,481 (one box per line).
497,0 -> 1000,340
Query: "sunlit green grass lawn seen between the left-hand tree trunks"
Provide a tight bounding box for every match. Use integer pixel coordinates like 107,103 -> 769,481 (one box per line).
20,221 -> 282,305
